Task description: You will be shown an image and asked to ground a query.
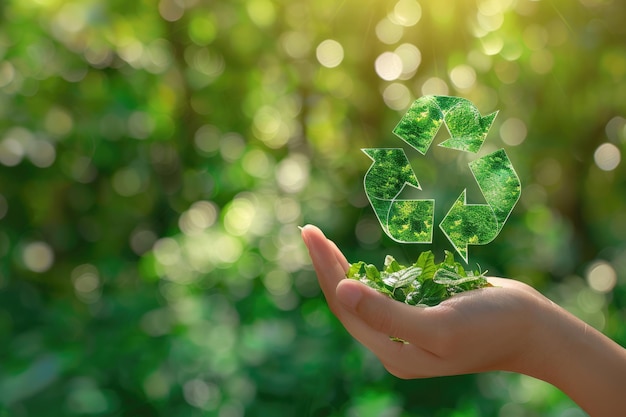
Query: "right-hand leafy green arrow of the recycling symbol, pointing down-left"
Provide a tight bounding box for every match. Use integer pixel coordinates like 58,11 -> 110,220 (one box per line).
439,149 -> 521,262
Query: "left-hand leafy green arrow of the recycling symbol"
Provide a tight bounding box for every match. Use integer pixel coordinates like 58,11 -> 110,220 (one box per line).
362,148 -> 435,243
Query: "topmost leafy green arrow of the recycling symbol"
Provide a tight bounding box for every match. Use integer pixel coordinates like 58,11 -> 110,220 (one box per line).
393,96 -> 498,155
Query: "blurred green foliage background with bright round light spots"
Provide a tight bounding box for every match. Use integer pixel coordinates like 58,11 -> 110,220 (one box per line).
0,0 -> 626,417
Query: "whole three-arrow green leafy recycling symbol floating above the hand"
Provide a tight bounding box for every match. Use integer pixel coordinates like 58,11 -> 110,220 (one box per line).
362,96 -> 521,263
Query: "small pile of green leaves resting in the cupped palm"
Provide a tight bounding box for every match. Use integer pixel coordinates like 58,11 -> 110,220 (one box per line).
346,251 -> 491,306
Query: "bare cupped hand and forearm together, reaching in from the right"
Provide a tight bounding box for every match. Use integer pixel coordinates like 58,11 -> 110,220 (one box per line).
302,225 -> 626,417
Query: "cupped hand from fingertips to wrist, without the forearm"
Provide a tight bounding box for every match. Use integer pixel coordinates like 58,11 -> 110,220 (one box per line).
302,226 -> 554,378
